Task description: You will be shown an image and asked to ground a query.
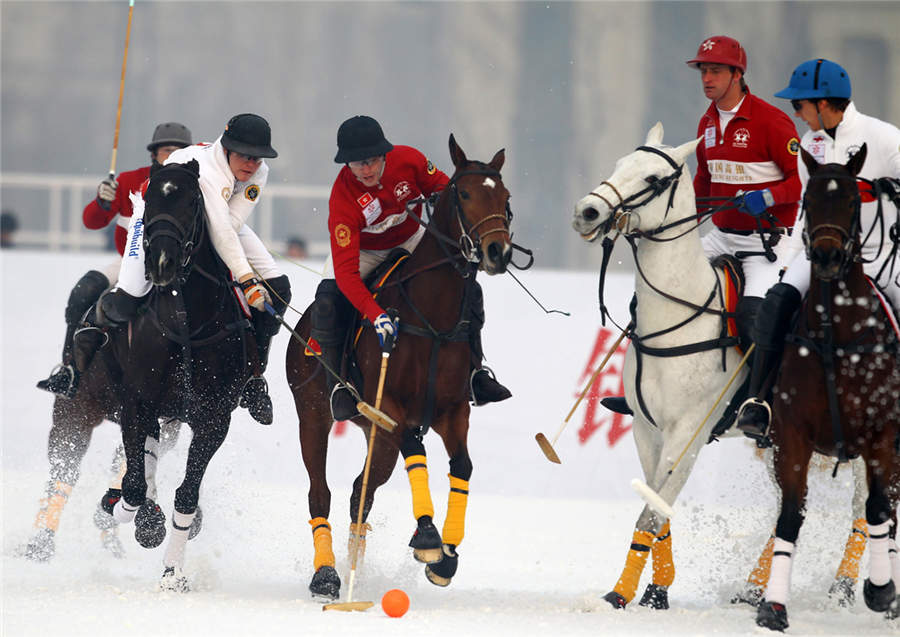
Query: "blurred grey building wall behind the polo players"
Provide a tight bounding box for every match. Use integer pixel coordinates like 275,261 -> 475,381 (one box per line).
0,0 -> 900,268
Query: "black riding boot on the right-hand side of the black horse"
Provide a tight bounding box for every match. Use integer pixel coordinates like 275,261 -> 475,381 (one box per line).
240,275 -> 291,425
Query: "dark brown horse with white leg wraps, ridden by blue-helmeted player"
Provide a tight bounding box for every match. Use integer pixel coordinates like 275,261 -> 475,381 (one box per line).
756,145 -> 900,630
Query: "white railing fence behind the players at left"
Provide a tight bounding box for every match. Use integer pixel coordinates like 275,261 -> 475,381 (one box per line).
0,173 -> 330,256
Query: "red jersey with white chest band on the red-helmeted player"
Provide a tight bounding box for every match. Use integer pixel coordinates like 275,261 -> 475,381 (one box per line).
694,93 -> 800,230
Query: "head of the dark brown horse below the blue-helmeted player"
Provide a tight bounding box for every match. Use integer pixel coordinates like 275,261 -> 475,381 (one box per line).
800,144 -> 867,281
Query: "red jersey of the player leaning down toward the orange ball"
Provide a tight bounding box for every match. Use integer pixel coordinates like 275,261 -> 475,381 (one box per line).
328,146 -> 450,319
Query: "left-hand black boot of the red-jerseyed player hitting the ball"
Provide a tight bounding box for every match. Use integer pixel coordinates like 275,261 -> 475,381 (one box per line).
309,279 -> 359,421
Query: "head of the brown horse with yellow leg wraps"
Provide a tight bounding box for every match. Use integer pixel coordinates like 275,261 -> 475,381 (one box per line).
445,135 -> 512,274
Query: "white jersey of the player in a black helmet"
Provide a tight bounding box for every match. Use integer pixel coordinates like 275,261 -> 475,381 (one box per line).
165,136 -> 269,279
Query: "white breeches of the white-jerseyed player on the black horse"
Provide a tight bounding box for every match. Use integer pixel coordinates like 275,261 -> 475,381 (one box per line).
116,200 -> 281,297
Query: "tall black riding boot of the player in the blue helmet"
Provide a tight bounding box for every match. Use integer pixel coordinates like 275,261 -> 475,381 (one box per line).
737,283 -> 802,442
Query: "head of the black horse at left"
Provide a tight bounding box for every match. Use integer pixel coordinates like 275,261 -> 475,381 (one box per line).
144,159 -> 203,287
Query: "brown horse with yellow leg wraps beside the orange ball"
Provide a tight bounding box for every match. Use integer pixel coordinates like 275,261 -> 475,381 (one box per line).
287,135 -> 512,599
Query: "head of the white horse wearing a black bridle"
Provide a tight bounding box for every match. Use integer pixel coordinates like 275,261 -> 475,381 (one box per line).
572,122 -> 700,241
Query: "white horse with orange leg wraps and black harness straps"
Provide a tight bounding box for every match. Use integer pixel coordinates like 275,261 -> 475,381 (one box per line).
572,123 -> 865,608
